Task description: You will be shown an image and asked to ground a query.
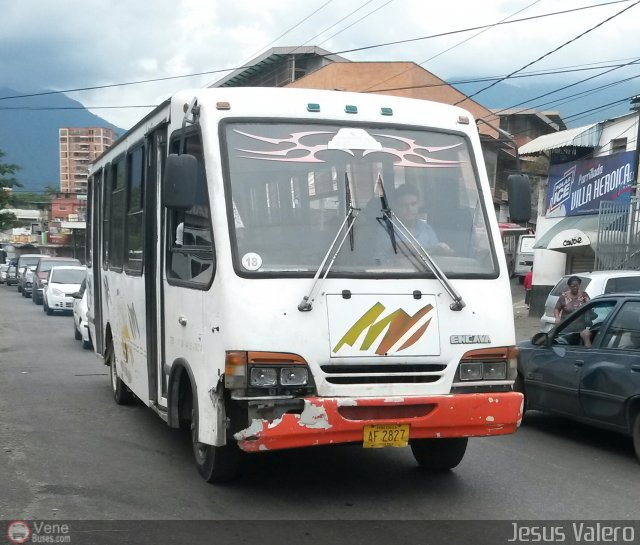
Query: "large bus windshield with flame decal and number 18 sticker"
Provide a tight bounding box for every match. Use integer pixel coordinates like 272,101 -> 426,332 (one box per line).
224,123 -> 497,277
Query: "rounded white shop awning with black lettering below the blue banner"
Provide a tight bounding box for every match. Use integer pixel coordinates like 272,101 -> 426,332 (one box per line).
533,212 -> 625,253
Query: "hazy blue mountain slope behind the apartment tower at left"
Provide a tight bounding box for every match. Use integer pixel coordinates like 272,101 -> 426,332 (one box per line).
0,87 -> 125,192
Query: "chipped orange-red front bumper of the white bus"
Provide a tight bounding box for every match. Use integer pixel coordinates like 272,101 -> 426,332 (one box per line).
235,392 -> 523,452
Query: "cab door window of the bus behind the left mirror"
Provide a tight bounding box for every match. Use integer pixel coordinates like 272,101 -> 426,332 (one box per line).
167,135 -> 215,288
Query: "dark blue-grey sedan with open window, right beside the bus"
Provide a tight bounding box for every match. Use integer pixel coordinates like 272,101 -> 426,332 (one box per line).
514,293 -> 640,461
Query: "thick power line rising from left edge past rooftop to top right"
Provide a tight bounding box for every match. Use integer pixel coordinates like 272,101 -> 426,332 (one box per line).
0,0 -> 635,101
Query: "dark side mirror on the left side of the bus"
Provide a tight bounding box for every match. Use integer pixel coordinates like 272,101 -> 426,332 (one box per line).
162,153 -> 199,210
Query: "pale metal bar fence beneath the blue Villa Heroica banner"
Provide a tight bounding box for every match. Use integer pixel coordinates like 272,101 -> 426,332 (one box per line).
594,197 -> 640,271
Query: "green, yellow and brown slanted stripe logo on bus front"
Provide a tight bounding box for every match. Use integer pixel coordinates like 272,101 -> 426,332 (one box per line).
333,303 -> 433,356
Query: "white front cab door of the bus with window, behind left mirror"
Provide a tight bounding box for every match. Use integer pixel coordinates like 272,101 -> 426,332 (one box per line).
160,129 -> 215,397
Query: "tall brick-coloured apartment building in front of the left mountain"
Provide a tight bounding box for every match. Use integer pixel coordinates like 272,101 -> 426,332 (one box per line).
59,127 -> 116,193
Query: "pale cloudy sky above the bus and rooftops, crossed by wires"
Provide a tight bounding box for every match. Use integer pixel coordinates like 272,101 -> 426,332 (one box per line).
0,0 -> 640,129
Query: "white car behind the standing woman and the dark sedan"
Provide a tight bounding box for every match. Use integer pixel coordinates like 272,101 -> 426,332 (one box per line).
540,271 -> 640,333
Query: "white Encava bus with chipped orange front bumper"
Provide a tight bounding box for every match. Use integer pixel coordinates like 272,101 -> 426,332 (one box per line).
87,88 -> 529,482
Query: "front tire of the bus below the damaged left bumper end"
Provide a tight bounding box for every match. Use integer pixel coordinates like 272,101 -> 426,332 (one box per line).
191,404 -> 241,484
